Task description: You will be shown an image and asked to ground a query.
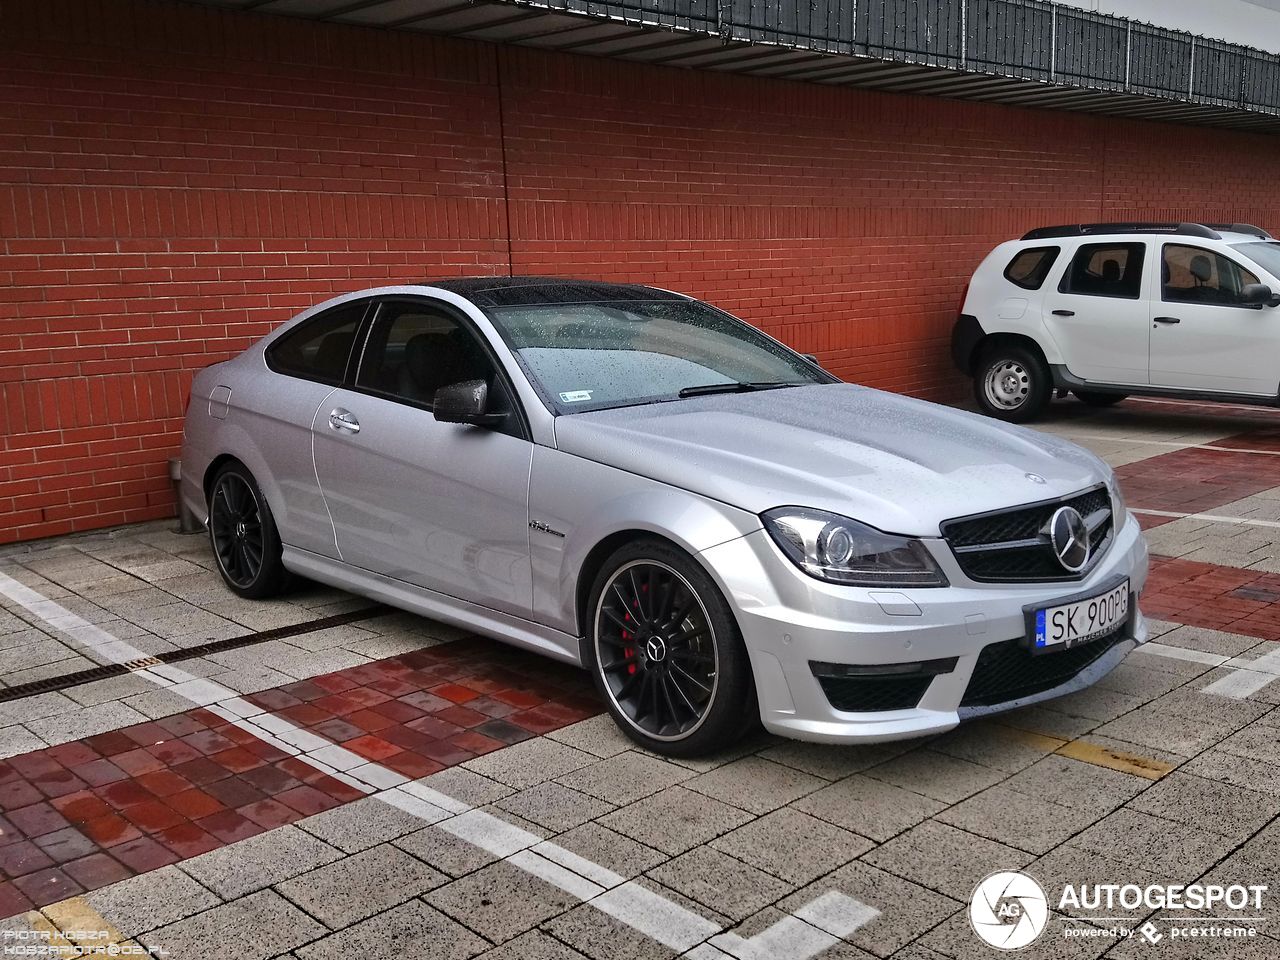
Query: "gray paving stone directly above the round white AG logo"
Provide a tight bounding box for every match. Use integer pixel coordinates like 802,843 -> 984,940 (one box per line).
937,783 -> 1101,854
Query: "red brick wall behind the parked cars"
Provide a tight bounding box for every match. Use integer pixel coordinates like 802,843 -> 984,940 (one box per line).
0,0 -> 1280,541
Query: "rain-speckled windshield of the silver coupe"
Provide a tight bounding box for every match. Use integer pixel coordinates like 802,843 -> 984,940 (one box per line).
488,301 -> 833,413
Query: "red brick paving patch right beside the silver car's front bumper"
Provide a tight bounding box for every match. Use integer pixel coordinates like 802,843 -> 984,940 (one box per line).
1142,557 -> 1280,640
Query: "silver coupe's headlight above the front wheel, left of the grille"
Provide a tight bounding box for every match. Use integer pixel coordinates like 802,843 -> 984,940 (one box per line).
760,507 -> 947,586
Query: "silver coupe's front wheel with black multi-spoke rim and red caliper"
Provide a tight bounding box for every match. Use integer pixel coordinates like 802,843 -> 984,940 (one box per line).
582,538 -> 759,756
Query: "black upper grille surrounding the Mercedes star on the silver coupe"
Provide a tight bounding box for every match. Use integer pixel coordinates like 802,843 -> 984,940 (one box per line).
942,486 -> 1112,584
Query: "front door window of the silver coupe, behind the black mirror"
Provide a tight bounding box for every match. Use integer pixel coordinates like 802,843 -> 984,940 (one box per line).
356,301 -> 512,424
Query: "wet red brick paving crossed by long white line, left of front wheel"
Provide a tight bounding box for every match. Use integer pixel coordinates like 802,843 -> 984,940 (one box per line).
0,639 -> 600,918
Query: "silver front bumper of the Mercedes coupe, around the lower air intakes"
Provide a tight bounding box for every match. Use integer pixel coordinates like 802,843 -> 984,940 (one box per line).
701,516 -> 1147,742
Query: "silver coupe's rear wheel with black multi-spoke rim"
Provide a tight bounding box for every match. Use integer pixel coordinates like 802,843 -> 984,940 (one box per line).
209,461 -> 288,600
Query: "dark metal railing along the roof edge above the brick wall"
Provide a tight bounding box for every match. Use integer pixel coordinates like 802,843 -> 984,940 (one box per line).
513,0 -> 1280,115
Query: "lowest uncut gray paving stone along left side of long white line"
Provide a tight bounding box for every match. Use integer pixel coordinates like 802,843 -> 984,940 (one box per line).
424,860 -> 581,943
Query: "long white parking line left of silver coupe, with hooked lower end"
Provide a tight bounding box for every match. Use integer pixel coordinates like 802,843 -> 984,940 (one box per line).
0,572 -> 879,960
